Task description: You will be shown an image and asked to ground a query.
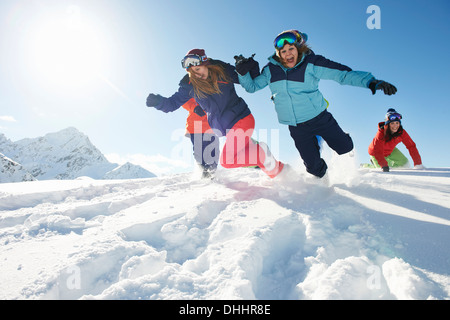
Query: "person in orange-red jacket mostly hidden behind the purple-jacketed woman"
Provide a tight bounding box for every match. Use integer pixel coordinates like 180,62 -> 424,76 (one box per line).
182,98 -> 220,178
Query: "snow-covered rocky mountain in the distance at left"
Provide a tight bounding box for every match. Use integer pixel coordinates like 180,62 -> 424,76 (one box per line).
0,128 -> 155,182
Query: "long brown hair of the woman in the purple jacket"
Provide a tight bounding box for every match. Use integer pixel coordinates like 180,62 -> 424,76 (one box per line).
188,63 -> 231,98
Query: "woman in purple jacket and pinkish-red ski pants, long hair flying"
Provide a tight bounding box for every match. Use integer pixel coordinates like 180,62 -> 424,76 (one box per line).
147,49 -> 284,178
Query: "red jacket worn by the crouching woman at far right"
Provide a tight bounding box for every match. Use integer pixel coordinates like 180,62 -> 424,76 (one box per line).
369,122 -> 422,167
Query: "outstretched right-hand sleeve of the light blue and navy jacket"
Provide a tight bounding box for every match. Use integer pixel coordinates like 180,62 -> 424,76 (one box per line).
311,55 -> 375,88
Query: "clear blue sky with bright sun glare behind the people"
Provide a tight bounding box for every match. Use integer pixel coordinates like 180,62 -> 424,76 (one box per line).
0,0 -> 450,174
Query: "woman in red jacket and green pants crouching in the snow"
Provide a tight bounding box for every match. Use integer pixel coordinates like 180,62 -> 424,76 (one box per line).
369,108 -> 423,172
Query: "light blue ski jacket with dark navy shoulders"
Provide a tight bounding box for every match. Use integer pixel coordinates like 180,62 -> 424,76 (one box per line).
239,50 -> 375,126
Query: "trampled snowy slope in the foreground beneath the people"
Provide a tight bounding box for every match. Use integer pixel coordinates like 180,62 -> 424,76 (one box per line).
0,163 -> 450,299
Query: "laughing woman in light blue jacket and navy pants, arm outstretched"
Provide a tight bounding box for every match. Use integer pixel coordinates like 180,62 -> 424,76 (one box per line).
236,30 -> 397,178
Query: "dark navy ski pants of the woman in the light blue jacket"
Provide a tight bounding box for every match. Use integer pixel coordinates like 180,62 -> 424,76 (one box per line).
289,110 -> 353,178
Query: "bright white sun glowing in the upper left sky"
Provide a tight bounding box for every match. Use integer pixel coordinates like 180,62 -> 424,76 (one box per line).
28,6 -> 107,87
